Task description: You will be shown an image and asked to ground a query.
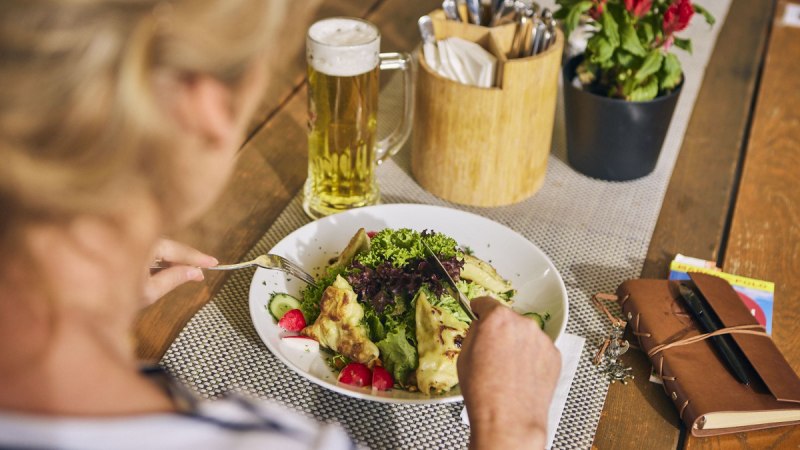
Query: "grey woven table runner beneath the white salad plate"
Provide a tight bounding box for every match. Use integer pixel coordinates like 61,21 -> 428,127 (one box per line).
161,0 -> 730,449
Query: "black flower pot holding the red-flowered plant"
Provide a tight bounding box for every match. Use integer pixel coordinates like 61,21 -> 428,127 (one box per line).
562,55 -> 683,181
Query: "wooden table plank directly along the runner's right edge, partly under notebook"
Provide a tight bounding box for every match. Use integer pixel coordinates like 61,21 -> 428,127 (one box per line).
594,0 -> 772,449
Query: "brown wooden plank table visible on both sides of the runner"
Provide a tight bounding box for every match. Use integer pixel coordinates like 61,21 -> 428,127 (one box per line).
135,0 -> 800,449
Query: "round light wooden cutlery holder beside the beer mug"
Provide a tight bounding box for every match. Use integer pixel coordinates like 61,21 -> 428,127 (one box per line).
411,11 -> 564,206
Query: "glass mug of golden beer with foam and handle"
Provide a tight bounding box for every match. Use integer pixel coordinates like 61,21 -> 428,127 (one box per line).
303,17 -> 413,218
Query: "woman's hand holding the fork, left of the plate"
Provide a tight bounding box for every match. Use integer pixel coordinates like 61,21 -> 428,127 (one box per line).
144,239 -> 219,304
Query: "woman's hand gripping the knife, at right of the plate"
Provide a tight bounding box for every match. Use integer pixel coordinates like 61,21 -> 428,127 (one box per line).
458,297 -> 561,449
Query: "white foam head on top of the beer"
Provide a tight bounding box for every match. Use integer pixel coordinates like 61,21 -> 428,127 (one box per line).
306,17 -> 381,77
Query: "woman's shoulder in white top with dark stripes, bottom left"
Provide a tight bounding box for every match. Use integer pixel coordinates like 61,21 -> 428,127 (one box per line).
0,395 -> 354,450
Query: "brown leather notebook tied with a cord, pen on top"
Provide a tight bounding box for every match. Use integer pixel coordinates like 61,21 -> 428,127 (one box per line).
617,273 -> 800,436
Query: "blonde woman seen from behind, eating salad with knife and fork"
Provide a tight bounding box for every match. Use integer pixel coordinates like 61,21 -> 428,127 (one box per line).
0,0 -> 559,450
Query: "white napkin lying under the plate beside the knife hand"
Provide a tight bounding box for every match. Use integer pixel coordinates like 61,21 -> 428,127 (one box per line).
461,333 -> 586,449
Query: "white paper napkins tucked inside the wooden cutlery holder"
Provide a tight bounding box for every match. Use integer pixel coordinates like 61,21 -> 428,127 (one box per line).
422,37 -> 497,87
